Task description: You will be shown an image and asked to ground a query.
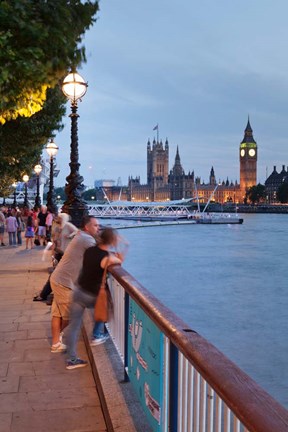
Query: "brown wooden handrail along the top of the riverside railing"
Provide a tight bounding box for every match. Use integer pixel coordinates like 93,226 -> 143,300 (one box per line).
109,266 -> 288,432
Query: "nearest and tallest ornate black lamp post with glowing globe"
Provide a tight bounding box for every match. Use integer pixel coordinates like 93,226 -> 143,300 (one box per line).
62,71 -> 88,227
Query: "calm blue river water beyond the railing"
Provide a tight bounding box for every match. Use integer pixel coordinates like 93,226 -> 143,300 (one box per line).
101,214 -> 288,408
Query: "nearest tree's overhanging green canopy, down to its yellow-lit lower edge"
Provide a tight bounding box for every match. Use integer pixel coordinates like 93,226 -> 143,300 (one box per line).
0,0 -> 98,124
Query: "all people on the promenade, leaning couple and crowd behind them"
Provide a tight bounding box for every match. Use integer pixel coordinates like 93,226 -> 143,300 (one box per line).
0,205 -> 128,369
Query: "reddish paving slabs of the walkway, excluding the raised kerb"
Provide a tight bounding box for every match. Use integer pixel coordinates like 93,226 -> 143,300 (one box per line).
0,245 -> 107,432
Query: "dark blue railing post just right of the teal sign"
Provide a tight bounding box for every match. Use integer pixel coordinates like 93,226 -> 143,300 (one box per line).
169,343 -> 178,432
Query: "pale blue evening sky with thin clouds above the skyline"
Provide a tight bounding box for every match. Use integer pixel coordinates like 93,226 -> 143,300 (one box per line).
55,0 -> 288,186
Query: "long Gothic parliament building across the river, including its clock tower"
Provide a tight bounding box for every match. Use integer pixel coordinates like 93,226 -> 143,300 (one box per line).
96,119 -> 257,203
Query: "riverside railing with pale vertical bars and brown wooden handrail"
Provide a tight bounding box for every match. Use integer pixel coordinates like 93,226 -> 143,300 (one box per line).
109,266 -> 288,432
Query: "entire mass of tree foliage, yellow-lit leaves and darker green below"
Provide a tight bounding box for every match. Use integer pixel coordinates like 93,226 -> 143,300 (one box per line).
0,0 -> 98,186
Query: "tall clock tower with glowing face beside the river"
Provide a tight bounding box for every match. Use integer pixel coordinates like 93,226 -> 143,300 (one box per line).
239,117 -> 257,194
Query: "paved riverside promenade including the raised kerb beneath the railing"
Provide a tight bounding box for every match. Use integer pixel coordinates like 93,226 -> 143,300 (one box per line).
0,245 -> 149,432
